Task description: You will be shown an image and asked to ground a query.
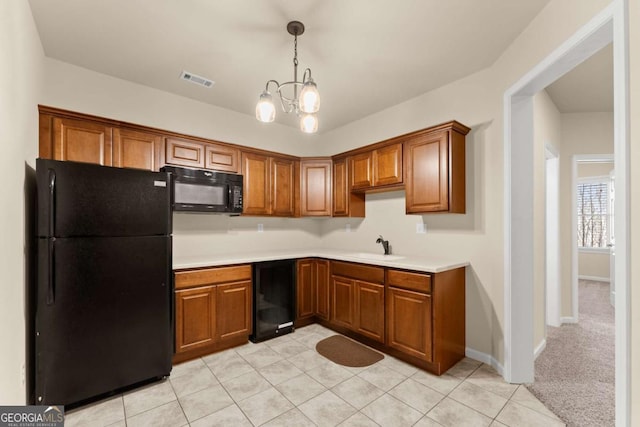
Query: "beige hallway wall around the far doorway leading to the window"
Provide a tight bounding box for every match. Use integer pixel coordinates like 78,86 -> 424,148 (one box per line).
560,113 -> 613,317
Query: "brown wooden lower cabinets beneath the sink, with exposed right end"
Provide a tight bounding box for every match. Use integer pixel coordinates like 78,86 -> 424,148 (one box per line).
320,261 -> 465,375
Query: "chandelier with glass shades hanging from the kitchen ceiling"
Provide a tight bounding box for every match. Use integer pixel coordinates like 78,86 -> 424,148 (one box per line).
256,21 -> 320,133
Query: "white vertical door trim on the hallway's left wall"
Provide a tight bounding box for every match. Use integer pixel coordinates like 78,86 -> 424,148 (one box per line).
544,144 -> 562,330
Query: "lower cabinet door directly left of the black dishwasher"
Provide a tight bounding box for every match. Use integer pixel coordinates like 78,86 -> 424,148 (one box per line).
216,281 -> 252,340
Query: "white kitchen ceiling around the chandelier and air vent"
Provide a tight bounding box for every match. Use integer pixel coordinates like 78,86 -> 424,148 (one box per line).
30,0 -> 608,132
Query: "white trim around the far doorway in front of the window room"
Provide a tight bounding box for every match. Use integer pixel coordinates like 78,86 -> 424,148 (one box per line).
564,154 -> 615,323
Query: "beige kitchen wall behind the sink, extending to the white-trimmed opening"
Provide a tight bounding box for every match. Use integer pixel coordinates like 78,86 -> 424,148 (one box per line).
323,0 -> 609,363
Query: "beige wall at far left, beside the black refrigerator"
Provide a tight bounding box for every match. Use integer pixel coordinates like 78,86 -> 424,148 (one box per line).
0,0 -> 44,405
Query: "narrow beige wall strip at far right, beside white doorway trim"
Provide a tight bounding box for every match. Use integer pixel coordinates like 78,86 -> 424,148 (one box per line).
628,0 -> 640,426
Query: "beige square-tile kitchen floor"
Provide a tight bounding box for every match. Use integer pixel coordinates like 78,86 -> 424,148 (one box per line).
65,325 -> 564,427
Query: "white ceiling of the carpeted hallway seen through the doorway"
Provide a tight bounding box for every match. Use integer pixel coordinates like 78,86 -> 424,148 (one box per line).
546,44 -> 613,113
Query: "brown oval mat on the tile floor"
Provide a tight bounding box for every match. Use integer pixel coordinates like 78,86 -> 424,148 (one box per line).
316,335 -> 384,368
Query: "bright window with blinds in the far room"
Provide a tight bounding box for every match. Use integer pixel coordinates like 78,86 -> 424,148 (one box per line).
578,181 -> 610,248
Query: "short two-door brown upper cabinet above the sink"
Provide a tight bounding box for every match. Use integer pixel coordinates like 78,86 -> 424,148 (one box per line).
350,143 -> 402,191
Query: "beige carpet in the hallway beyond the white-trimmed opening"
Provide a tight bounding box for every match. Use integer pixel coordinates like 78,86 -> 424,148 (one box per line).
527,280 -> 615,427
